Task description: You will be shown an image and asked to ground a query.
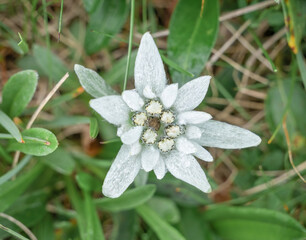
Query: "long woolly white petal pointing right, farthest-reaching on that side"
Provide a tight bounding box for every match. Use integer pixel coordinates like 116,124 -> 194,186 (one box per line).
196,120 -> 261,149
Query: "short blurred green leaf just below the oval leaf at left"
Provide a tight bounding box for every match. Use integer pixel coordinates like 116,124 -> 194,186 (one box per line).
41,148 -> 75,175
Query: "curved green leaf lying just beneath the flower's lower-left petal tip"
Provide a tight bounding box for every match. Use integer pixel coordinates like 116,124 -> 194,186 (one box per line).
95,185 -> 156,212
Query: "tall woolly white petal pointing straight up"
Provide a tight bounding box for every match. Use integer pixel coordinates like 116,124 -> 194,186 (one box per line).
134,32 -> 167,95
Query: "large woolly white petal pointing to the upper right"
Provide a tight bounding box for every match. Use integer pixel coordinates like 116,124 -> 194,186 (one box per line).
173,76 -> 211,112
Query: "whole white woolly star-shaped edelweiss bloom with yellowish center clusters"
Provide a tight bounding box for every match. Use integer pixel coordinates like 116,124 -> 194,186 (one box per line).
74,33 -> 261,198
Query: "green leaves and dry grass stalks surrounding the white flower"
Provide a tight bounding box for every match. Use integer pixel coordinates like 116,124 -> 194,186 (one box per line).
0,0 -> 306,240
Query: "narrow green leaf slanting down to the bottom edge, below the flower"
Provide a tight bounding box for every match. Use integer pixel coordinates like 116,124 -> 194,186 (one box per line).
136,205 -> 185,240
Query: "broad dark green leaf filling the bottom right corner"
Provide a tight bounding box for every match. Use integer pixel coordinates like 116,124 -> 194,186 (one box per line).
204,207 -> 306,240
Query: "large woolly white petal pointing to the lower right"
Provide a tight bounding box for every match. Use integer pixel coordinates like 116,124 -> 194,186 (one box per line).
165,150 -> 211,192
